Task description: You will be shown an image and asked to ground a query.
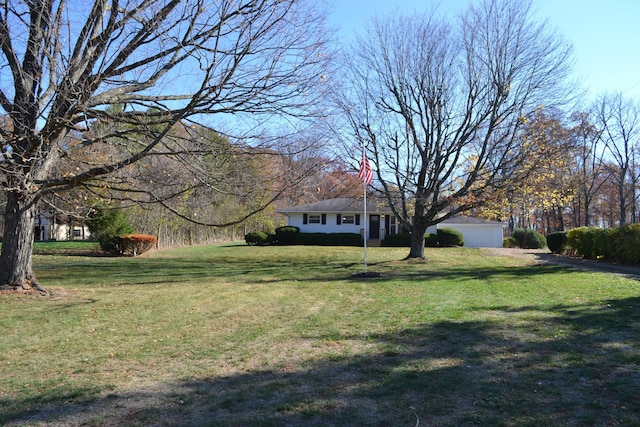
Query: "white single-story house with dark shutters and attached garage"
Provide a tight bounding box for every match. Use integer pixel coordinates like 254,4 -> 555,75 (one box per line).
279,197 -> 505,248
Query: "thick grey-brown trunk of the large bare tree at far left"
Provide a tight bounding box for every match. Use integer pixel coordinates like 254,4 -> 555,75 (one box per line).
0,193 -> 46,293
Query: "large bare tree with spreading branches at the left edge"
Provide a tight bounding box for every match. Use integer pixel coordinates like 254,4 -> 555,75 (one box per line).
0,0 -> 329,288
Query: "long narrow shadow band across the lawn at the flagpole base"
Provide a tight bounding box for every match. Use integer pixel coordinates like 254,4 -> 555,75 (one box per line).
36,252 -> 575,286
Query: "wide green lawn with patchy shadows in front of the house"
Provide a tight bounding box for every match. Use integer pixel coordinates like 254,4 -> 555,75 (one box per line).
0,244 -> 640,426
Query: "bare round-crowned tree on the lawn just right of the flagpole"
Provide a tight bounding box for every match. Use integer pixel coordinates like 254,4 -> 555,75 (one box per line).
338,0 -> 572,258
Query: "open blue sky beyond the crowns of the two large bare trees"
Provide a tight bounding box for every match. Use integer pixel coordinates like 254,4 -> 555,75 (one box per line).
330,0 -> 640,100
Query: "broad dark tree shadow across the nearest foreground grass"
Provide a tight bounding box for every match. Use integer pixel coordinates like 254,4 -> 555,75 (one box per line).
5,298 -> 640,426
